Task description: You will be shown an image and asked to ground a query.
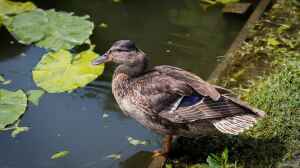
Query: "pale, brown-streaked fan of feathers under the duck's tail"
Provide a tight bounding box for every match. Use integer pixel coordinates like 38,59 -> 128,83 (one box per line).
212,114 -> 257,135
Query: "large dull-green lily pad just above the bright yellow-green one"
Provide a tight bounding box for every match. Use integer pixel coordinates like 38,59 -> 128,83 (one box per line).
8,9 -> 94,50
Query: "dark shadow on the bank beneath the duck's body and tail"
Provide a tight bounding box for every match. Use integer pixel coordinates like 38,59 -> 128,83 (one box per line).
170,135 -> 287,168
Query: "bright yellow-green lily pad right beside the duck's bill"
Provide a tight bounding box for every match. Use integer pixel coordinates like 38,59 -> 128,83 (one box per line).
32,49 -> 104,93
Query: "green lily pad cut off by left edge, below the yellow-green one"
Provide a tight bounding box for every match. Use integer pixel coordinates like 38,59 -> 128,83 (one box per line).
0,89 -> 27,130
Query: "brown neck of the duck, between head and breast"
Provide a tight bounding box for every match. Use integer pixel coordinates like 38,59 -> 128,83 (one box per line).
114,51 -> 148,79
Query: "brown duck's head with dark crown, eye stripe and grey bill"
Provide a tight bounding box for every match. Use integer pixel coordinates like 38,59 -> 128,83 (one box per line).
92,40 -> 143,65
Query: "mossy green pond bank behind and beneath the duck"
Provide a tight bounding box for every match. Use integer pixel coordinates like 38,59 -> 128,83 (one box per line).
170,0 -> 300,168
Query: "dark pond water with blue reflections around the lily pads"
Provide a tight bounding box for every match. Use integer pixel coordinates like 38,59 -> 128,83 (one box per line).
0,0 -> 244,168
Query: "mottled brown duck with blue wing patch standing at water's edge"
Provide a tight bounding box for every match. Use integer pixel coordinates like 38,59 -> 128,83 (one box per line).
92,40 -> 265,156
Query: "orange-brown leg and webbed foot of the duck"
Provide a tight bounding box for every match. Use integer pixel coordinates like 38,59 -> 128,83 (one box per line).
152,135 -> 173,158
